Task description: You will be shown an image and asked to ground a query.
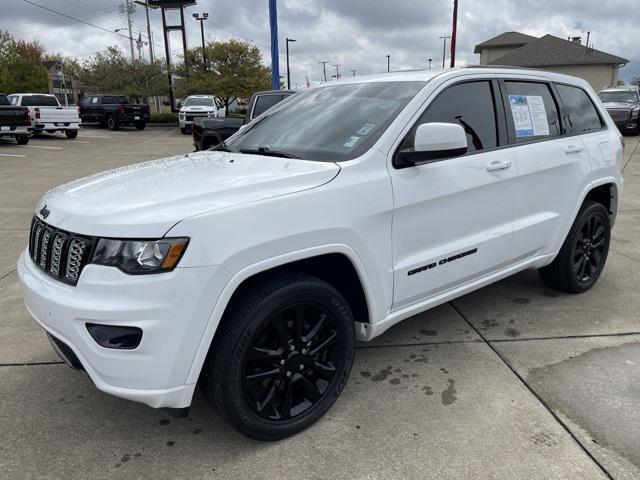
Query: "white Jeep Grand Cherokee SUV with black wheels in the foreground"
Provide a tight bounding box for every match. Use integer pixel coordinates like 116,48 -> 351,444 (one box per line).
18,68 -> 622,440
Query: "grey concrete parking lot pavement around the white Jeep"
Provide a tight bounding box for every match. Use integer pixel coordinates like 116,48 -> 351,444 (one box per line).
0,127 -> 640,480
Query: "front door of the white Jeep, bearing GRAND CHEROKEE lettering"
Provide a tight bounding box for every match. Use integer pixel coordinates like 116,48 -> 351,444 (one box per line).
389,79 -> 515,309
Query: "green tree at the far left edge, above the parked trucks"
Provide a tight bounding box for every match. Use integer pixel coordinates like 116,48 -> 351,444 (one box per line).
0,31 -> 49,94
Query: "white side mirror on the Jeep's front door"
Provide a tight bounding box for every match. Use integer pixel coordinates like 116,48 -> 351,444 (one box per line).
398,122 -> 467,167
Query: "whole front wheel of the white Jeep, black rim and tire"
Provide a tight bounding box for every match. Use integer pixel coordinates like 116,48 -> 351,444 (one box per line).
201,272 -> 355,441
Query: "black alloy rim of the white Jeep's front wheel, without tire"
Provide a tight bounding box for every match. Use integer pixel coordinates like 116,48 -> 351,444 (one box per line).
242,303 -> 344,421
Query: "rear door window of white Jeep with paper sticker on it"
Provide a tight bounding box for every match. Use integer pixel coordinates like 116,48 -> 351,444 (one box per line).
505,81 -> 562,143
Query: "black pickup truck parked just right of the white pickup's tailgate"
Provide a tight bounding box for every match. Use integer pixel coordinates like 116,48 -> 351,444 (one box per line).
80,95 -> 150,130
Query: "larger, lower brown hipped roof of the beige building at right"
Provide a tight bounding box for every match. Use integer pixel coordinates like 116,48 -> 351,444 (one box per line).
489,35 -> 629,67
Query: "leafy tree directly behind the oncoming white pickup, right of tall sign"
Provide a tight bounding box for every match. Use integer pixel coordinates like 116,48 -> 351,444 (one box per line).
176,40 -> 271,109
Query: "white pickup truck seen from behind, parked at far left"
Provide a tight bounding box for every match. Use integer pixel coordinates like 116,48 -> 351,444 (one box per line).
9,93 -> 81,138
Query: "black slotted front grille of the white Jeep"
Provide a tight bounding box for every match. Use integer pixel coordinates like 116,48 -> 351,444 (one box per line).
29,217 -> 95,285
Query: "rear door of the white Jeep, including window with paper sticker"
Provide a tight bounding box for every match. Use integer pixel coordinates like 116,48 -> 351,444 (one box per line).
501,79 -> 591,259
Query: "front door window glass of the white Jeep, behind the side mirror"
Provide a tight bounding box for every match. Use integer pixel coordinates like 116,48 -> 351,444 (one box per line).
400,81 -> 498,152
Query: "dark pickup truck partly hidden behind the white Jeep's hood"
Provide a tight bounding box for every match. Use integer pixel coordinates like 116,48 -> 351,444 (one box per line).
192,90 -> 295,151
